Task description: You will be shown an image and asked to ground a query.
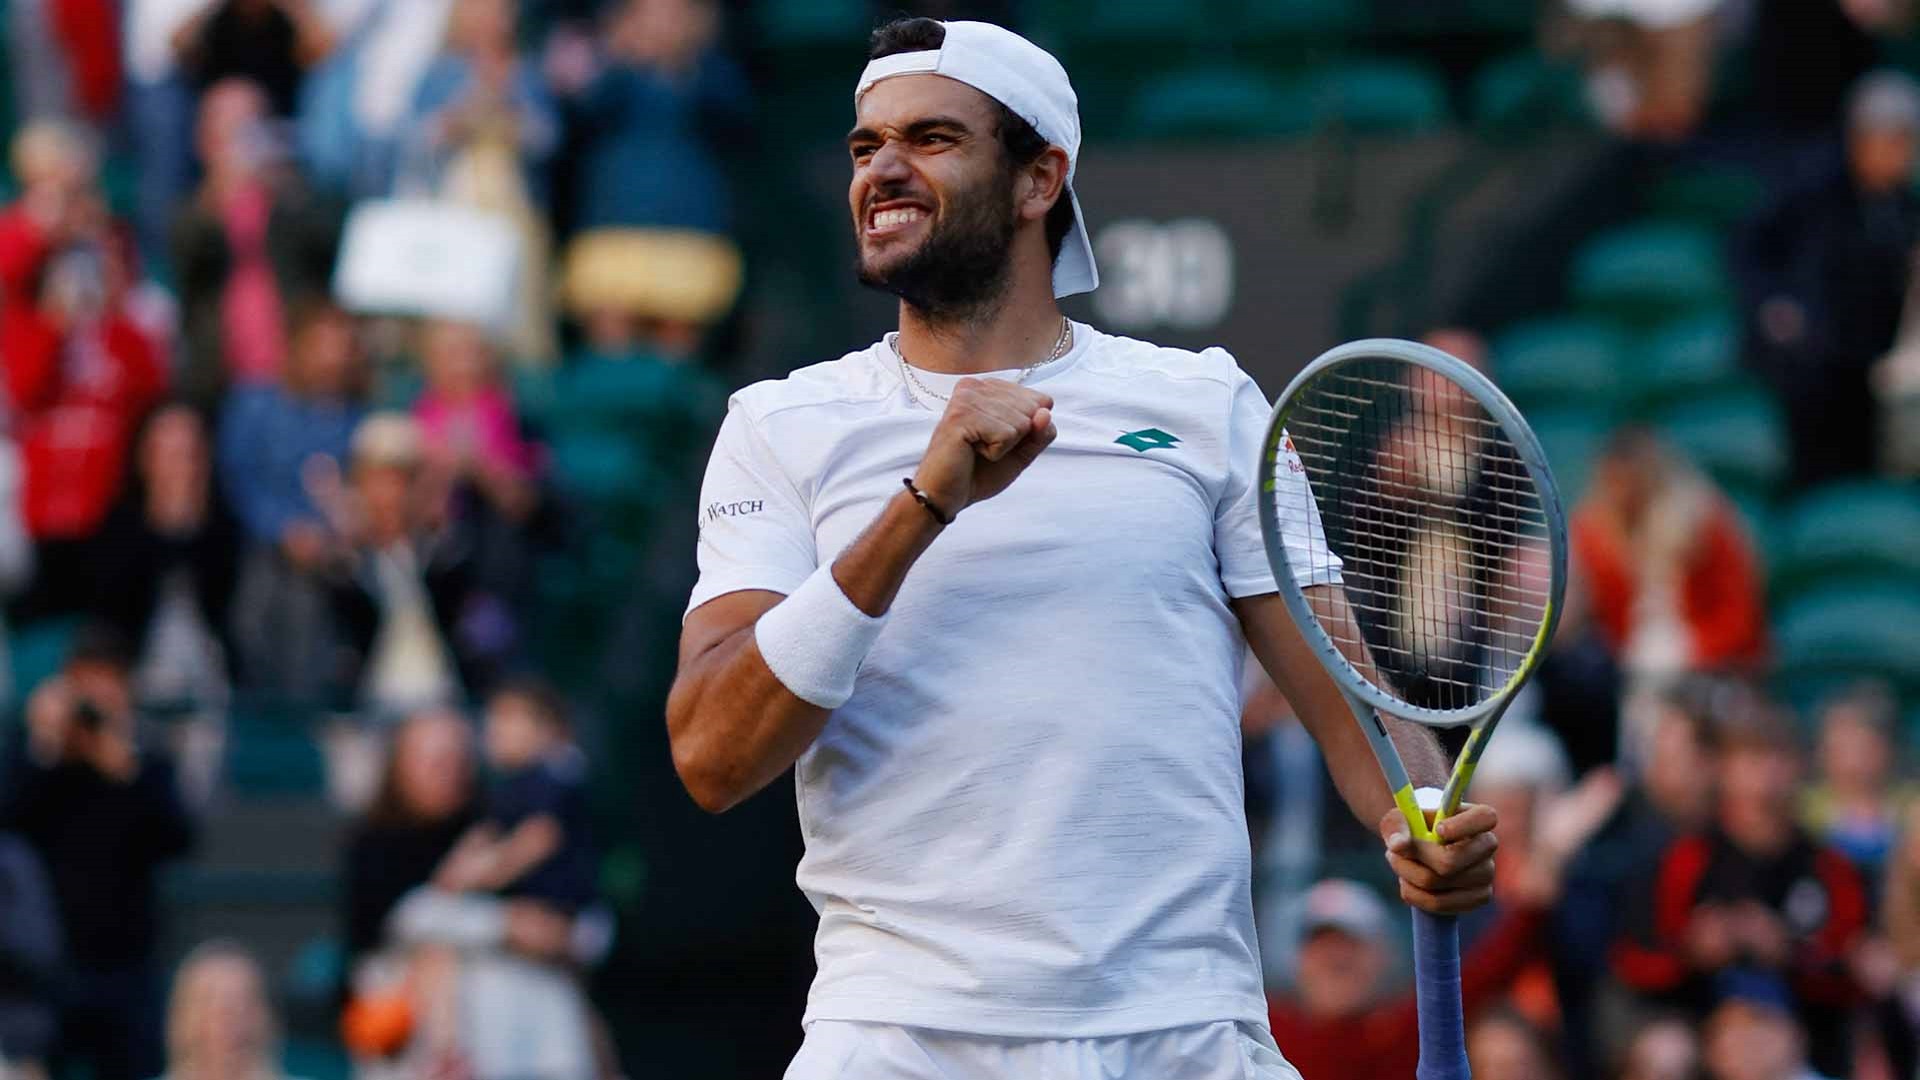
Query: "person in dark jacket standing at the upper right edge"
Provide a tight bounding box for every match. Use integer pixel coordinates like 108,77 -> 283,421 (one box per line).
1736,71 -> 1920,486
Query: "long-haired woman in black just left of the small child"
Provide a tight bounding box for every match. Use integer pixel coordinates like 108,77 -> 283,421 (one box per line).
340,709 -> 476,965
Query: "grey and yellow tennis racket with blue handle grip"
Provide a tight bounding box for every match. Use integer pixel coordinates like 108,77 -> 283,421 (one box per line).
1260,338 -> 1567,1080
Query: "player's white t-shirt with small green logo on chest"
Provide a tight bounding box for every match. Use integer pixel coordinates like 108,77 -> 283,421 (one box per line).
687,325 -> 1336,1038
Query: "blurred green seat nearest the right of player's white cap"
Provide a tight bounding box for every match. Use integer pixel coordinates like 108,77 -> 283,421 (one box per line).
1129,65 -> 1313,138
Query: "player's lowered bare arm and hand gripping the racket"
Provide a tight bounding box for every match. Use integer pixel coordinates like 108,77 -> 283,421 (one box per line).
1233,586 -> 1498,913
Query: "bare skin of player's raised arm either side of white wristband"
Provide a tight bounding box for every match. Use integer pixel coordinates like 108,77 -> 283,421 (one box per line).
666,488 -> 941,813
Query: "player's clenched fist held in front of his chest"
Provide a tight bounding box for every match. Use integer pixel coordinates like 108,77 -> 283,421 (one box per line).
914,379 -> 1060,515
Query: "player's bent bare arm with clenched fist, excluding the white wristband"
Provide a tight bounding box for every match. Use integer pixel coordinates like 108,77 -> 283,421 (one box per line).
666,379 -> 1056,813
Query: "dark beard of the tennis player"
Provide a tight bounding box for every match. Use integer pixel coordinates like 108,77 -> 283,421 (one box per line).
854,169 -> 1014,323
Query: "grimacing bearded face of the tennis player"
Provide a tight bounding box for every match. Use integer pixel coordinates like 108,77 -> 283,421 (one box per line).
847,75 -> 1016,317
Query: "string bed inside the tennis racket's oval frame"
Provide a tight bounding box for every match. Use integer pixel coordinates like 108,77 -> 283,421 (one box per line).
1273,357 -> 1553,711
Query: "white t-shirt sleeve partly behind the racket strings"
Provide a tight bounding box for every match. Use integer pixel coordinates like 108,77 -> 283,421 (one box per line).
1213,355 -> 1340,598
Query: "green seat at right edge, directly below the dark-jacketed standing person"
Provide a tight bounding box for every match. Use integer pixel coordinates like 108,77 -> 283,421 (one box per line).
1770,482 -> 1920,600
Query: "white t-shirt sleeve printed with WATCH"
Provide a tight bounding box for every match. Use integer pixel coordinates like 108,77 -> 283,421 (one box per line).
687,400 -> 818,611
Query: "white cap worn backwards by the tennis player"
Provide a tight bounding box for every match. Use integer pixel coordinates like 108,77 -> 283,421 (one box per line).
852,21 -> 1100,296
